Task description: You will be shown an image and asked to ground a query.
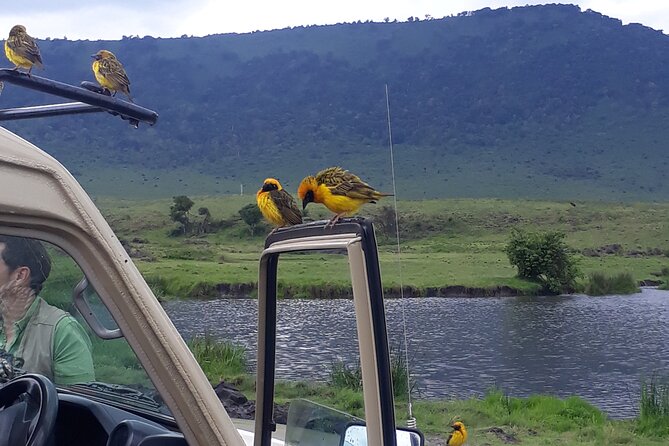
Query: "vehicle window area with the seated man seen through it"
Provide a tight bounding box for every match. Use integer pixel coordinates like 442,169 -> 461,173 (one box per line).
0,234 -> 169,414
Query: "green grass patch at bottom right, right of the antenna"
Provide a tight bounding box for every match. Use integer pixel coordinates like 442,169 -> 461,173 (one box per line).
397,390 -> 667,446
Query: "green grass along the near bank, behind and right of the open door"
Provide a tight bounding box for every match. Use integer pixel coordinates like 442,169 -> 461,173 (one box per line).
190,338 -> 669,446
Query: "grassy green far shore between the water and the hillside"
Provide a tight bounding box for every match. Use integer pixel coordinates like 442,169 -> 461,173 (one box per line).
97,196 -> 669,299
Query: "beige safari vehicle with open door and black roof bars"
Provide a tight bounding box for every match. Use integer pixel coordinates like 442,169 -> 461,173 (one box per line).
0,70 -> 424,446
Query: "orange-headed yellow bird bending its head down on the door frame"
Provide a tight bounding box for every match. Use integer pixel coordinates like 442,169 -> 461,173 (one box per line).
297,167 -> 392,225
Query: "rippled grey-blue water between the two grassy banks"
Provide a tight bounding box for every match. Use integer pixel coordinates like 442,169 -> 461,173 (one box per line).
165,289 -> 669,417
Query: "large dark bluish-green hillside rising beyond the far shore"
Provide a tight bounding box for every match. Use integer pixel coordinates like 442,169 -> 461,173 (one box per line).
0,5 -> 669,201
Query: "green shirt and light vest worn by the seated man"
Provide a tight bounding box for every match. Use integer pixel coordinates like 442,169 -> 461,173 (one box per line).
0,296 -> 95,385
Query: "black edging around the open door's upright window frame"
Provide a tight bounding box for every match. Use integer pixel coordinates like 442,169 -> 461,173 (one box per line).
256,217 -> 396,446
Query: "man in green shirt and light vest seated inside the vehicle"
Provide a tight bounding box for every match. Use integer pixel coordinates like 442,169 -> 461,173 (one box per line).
0,235 -> 95,385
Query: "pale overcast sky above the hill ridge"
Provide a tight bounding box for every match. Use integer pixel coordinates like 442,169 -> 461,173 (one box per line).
0,0 -> 669,40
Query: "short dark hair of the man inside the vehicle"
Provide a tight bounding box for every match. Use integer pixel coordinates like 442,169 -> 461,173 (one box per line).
0,235 -> 51,294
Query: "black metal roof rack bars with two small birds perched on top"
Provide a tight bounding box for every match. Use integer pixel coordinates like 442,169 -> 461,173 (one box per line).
0,68 -> 158,128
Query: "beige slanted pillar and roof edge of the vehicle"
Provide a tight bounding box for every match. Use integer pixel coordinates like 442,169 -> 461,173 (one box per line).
0,128 -> 244,445
